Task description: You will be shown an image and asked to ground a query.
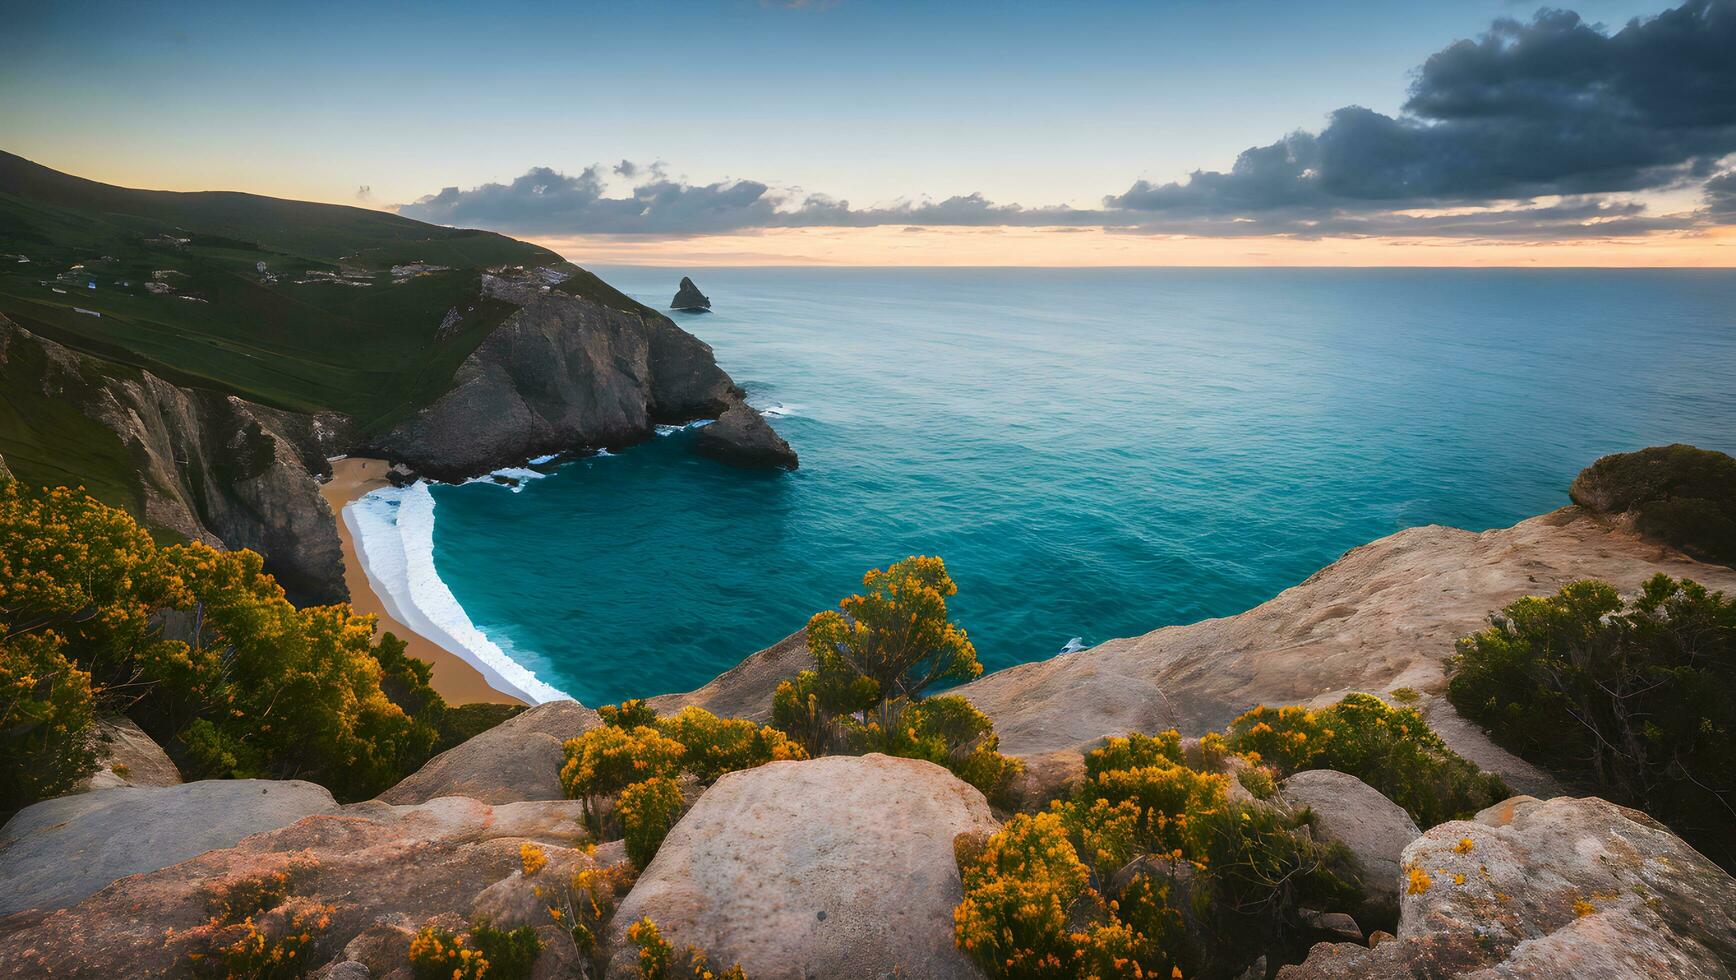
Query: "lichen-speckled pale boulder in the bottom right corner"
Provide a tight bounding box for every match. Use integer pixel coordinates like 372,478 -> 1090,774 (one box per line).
1279,796 -> 1736,980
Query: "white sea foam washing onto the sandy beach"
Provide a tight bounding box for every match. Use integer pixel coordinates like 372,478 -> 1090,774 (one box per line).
344,474 -> 571,704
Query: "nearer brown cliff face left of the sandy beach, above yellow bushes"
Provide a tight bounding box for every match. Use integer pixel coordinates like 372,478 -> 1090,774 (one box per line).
0,317 -> 349,604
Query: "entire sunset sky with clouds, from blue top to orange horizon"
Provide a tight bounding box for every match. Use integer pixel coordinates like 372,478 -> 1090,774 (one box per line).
0,0 -> 1736,265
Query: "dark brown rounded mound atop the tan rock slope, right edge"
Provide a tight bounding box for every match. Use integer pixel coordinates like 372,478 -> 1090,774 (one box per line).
1568,444 -> 1736,565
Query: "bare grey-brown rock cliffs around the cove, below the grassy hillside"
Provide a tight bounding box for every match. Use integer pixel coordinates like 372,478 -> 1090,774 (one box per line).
0,267 -> 795,604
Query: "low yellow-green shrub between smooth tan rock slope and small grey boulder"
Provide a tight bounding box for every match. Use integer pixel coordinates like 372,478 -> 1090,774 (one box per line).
1229,694 -> 1512,829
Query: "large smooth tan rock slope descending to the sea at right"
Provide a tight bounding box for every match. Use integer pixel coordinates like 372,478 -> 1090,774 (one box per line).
955,506 -> 1736,794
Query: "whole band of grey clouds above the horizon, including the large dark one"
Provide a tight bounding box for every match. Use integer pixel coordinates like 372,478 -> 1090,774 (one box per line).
399,0 -> 1736,239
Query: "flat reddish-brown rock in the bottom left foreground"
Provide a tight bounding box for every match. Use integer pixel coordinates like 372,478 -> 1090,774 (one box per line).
0,789 -> 590,980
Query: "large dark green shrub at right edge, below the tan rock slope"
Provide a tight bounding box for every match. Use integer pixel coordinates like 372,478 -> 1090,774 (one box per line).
1448,574 -> 1736,867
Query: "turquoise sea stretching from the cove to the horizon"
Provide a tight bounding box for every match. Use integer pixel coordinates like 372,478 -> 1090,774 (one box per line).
434,269 -> 1736,704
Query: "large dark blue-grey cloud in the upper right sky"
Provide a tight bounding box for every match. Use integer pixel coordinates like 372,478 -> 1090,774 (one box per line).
1104,0 -> 1736,215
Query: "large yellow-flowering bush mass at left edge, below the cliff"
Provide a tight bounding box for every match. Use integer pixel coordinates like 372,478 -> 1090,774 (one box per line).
0,480 -> 446,812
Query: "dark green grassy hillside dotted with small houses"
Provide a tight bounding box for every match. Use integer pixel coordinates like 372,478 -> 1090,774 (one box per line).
0,153 -> 561,430
